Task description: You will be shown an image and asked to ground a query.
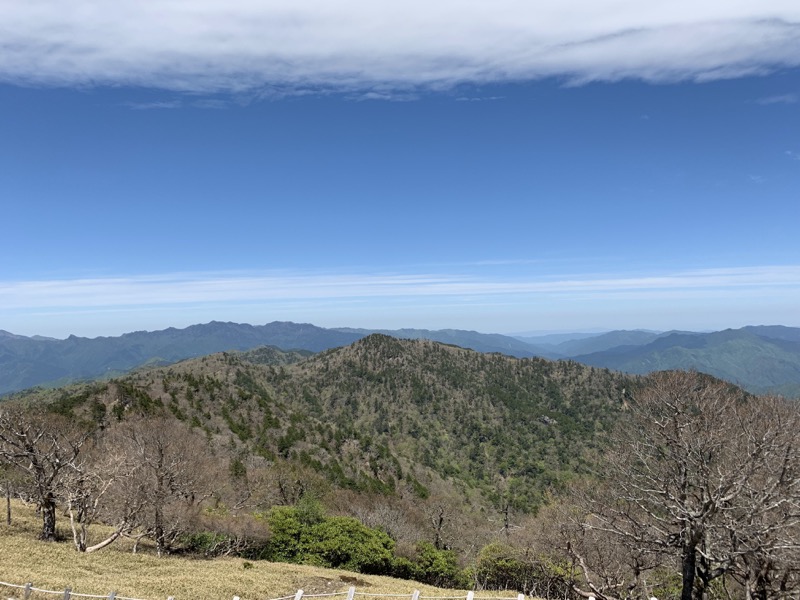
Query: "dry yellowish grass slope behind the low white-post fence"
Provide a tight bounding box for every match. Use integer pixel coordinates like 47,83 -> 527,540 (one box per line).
0,503 -> 513,600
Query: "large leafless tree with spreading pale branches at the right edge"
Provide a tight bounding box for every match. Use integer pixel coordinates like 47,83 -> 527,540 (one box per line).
585,372 -> 800,600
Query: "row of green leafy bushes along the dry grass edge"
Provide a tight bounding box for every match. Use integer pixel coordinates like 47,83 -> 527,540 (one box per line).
183,498 -> 573,598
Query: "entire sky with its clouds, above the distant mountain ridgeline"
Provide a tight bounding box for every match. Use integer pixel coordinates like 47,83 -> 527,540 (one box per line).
0,0 -> 800,337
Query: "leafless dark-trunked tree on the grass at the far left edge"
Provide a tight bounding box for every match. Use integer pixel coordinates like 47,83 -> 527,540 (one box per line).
0,406 -> 92,541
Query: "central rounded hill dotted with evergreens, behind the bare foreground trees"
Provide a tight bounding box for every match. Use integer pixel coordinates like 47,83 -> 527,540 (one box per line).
29,334 -> 635,511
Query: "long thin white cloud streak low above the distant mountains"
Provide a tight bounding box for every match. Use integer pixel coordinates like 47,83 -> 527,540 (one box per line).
0,266 -> 800,311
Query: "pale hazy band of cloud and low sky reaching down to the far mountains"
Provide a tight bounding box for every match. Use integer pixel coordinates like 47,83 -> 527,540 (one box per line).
0,265 -> 800,337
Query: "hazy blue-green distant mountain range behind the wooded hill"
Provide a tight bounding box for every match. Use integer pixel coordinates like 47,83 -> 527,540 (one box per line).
0,321 -> 800,397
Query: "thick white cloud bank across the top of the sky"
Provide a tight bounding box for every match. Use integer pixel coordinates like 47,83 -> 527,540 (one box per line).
0,0 -> 800,95
